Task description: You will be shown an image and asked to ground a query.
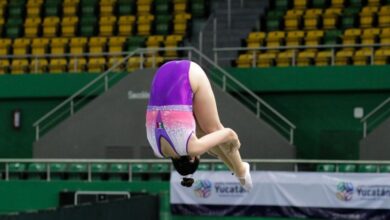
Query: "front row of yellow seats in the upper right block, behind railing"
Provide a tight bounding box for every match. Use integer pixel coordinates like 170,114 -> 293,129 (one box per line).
236,48 -> 390,68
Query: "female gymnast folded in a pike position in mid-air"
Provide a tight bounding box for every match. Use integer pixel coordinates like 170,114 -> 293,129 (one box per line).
146,60 -> 252,191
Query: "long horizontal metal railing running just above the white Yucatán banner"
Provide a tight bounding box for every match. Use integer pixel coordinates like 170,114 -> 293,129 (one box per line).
0,159 -> 390,182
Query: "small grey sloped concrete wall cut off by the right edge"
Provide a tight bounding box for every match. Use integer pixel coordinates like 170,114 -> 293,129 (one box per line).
360,118 -> 390,160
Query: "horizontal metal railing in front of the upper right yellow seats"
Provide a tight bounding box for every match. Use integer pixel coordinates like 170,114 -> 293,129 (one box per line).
213,44 -> 390,67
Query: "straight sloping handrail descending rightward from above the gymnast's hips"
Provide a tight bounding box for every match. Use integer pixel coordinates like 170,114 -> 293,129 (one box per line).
194,48 -> 296,129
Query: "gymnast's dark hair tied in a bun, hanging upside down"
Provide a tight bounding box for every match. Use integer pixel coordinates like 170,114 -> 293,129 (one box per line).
171,156 -> 199,187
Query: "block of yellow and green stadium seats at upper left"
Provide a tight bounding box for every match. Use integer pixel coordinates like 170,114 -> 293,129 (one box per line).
0,0 -> 206,74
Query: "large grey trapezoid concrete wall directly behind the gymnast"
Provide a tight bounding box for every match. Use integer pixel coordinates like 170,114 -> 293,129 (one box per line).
33,69 -> 295,162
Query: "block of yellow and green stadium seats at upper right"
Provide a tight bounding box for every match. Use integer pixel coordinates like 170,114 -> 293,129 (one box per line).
236,0 -> 390,67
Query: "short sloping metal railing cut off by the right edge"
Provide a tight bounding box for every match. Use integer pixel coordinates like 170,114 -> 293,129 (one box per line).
360,97 -> 390,138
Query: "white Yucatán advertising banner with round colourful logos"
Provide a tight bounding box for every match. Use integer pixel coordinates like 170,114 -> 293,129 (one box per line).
170,171 -> 390,219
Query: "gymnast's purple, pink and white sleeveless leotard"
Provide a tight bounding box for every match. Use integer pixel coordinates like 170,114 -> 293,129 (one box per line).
146,60 -> 196,157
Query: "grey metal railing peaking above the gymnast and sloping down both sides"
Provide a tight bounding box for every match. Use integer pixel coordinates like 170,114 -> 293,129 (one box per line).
33,47 -> 296,144
